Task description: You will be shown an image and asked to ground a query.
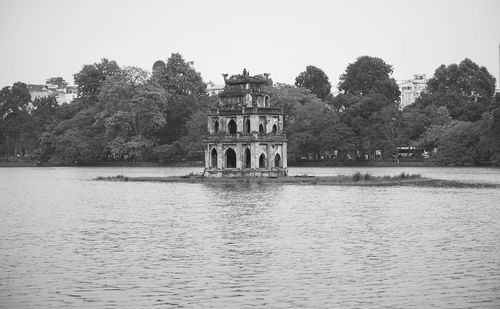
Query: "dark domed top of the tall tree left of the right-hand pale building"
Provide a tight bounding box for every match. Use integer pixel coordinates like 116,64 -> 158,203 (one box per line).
338,56 -> 401,102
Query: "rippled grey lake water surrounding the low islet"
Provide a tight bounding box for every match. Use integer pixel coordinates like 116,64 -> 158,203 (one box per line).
0,167 -> 500,308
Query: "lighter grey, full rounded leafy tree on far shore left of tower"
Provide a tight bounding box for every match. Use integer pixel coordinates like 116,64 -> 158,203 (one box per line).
96,67 -> 167,160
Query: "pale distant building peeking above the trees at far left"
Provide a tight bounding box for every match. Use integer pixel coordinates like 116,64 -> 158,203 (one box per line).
28,77 -> 78,104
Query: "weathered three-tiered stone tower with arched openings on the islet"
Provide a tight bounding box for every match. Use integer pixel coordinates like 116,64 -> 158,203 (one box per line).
204,70 -> 288,177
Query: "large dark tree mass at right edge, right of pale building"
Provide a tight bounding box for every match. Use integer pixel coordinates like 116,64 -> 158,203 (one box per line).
403,59 -> 500,164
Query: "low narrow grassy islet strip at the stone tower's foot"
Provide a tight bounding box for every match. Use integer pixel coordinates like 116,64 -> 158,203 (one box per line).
93,175 -> 500,188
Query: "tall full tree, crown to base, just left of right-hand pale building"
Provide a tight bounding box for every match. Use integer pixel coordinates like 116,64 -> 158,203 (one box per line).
327,56 -> 401,159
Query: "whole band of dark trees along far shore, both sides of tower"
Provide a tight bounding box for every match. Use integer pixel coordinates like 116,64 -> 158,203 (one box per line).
0,53 -> 500,164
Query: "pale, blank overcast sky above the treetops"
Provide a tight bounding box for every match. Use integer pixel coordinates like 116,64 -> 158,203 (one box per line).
0,0 -> 500,87
